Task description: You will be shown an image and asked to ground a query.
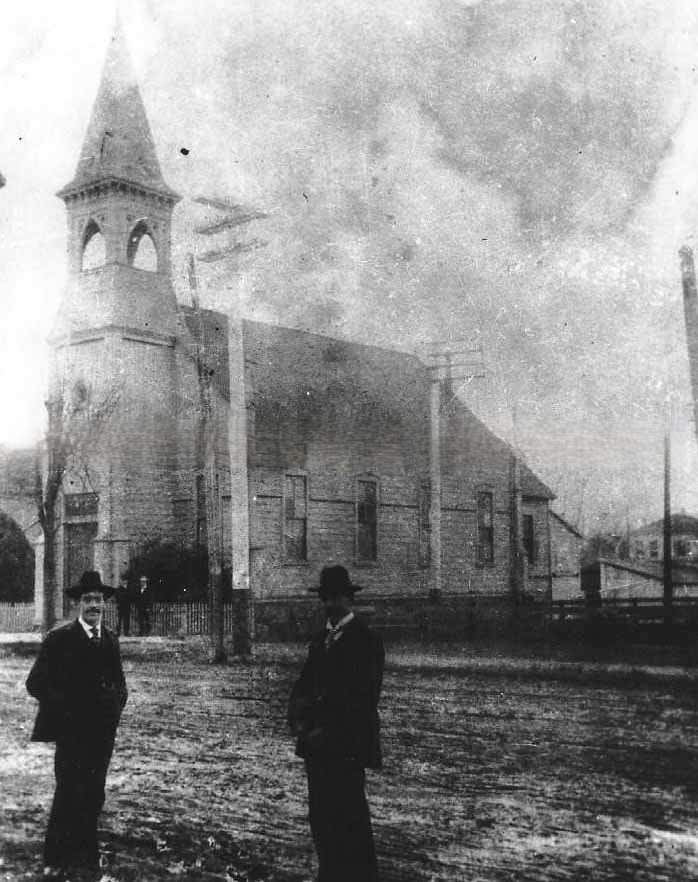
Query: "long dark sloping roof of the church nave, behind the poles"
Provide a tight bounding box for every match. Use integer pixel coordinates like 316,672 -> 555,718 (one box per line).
179,305 -> 556,496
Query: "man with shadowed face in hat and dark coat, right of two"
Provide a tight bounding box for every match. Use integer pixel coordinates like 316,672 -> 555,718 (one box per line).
288,566 -> 384,882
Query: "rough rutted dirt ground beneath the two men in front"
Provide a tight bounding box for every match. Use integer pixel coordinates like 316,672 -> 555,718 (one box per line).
0,638 -> 698,882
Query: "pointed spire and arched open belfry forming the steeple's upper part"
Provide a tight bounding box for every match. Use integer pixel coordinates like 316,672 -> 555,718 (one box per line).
55,19 -> 180,337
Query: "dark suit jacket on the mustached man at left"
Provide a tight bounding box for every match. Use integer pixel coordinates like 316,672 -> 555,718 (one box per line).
27,619 -> 128,741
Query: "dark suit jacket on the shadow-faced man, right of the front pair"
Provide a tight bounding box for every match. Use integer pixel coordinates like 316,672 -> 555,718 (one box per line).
288,618 -> 385,769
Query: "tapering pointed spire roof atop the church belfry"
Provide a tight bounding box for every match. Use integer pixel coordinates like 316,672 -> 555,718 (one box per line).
58,12 -> 178,199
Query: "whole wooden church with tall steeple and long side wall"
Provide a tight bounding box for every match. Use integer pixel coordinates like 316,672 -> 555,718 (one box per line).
37,18 -> 552,628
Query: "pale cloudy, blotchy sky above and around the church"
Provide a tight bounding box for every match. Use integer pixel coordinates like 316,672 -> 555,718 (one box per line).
0,0 -> 698,530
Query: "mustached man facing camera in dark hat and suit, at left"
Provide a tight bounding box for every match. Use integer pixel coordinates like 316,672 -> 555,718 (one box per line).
27,570 -> 127,880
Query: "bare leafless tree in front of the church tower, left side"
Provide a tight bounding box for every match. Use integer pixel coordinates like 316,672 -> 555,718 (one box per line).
34,383 -> 121,633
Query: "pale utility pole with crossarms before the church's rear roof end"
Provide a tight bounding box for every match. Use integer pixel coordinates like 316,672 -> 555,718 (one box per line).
427,341 -> 485,600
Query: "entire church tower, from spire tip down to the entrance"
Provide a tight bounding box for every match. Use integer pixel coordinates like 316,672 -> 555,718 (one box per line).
49,20 -> 182,594
